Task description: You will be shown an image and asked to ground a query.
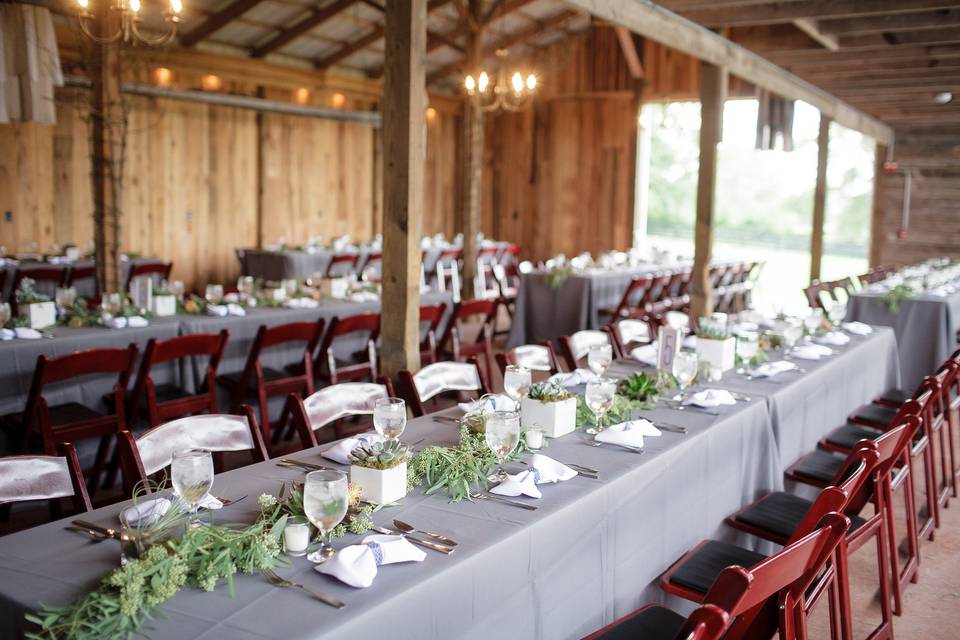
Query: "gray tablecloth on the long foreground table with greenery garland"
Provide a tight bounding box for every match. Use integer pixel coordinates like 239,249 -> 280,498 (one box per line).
0,329 -> 897,640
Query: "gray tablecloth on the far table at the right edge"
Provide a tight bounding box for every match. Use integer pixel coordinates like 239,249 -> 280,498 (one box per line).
847,293 -> 960,391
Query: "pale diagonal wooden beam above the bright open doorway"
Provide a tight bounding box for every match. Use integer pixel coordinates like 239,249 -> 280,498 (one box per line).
563,0 -> 893,143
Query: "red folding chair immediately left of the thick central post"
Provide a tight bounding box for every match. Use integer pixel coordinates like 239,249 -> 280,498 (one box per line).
316,313 -> 380,384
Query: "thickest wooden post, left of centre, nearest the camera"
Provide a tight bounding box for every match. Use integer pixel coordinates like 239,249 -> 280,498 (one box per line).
380,0 -> 427,377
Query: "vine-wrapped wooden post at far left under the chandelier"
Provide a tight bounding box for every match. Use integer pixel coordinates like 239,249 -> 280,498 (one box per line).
90,2 -> 127,293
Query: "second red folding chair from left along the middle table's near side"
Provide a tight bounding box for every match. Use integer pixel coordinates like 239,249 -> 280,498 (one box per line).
127,329 -> 230,427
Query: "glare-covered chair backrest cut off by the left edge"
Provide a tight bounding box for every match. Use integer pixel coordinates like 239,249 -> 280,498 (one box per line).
0,442 -> 93,513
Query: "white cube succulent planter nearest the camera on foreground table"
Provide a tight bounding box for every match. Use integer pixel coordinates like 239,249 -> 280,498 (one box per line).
350,440 -> 412,504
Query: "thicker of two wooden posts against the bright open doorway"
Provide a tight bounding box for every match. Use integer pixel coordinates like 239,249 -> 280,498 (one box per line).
690,62 -> 727,322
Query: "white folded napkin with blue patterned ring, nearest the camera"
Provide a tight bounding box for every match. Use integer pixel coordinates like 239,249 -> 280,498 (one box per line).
314,535 -> 427,589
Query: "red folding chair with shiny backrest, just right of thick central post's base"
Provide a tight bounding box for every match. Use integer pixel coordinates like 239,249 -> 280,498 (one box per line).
397,358 -> 490,417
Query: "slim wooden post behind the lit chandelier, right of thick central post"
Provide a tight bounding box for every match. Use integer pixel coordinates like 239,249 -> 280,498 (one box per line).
457,0 -> 483,300
